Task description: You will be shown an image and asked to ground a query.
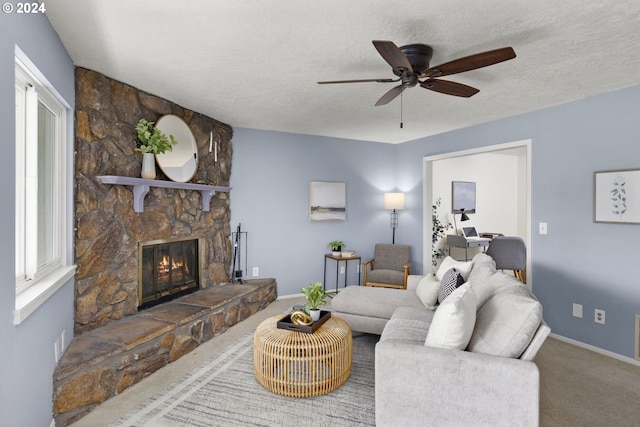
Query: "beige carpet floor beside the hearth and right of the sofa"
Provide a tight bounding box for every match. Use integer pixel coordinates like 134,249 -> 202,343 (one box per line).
74,298 -> 640,427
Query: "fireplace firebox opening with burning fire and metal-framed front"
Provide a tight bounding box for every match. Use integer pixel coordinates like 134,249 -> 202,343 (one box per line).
138,237 -> 201,309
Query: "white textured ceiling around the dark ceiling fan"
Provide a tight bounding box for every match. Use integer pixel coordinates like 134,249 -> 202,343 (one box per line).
45,0 -> 640,143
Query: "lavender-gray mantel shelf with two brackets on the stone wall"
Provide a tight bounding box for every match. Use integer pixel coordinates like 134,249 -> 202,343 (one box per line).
96,175 -> 231,212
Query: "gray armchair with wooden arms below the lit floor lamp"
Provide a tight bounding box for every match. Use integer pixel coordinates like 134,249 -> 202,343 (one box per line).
363,243 -> 411,289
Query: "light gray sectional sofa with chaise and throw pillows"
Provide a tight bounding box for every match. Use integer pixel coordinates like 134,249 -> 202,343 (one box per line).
331,254 -> 550,426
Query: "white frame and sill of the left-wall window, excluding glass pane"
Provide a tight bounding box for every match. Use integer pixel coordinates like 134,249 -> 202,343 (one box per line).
14,46 -> 75,324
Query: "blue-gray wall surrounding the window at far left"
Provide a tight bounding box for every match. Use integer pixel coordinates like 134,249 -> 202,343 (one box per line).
0,13 -> 75,426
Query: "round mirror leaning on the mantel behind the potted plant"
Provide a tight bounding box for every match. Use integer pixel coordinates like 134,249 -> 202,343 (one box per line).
155,114 -> 198,182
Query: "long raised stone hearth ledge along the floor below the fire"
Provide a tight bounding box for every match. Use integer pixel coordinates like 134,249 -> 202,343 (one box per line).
53,279 -> 276,426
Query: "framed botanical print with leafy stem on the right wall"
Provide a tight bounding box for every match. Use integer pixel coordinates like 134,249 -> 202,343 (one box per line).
593,169 -> 640,224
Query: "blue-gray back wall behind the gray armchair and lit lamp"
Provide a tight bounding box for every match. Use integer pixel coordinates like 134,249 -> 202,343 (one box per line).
231,129 -> 404,296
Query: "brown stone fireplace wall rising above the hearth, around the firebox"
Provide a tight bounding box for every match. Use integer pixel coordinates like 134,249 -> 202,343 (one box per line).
75,68 -> 233,334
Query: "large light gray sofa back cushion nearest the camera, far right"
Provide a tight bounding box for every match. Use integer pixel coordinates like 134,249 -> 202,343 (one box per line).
468,285 -> 542,358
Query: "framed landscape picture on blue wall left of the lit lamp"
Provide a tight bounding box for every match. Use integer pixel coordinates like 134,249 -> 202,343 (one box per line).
309,181 -> 347,222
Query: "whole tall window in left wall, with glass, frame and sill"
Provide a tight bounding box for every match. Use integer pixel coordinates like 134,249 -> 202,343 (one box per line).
14,51 -> 75,323
